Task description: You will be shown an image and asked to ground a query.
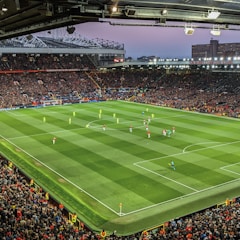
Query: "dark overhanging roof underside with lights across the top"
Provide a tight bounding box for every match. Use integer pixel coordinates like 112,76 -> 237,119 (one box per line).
0,0 -> 240,40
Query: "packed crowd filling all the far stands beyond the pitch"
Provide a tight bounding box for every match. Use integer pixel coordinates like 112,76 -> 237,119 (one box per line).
0,54 -> 240,117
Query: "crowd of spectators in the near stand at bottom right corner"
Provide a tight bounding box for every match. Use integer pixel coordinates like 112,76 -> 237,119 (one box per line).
155,199 -> 240,240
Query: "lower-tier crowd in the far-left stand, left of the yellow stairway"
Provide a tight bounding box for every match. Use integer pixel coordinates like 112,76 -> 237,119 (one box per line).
0,71 -> 99,108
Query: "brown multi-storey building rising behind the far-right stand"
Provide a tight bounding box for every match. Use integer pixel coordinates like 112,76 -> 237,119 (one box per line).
192,39 -> 240,59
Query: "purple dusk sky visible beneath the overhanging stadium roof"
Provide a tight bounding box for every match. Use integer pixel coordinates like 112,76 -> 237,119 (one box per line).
36,22 -> 240,59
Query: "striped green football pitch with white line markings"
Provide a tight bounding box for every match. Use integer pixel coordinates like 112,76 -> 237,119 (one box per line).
0,101 -> 240,235
